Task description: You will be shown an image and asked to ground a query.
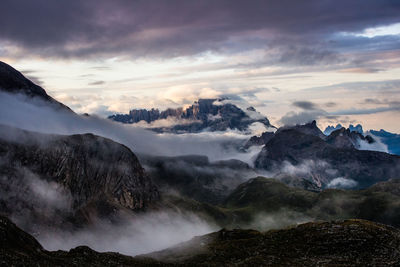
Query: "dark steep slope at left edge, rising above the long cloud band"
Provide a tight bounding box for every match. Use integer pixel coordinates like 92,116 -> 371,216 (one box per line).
0,61 -> 72,112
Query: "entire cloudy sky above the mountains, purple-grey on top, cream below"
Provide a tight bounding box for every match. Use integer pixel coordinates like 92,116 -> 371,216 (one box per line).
0,0 -> 400,132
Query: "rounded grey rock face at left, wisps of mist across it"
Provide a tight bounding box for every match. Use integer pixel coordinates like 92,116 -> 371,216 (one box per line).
0,126 -> 158,228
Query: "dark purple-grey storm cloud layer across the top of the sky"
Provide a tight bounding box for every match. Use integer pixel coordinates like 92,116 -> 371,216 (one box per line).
0,0 -> 400,58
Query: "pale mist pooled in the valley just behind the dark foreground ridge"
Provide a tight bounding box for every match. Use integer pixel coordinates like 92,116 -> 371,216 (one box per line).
37,212 -> 217,256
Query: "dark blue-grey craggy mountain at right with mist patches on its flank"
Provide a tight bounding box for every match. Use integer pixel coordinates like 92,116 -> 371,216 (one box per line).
255,128 -> 400,188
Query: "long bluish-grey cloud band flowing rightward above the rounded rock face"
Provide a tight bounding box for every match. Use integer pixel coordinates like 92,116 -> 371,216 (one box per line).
0,93 -> 260,164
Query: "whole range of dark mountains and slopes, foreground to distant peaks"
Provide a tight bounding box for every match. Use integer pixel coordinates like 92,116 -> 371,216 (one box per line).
0,60 -> 400,266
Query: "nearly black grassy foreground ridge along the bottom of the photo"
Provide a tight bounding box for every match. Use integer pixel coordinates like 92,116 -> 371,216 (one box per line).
0,217 -> 400,266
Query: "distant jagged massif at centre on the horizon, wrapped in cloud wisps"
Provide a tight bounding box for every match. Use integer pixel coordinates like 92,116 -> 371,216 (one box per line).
109,99 -> 273,133
